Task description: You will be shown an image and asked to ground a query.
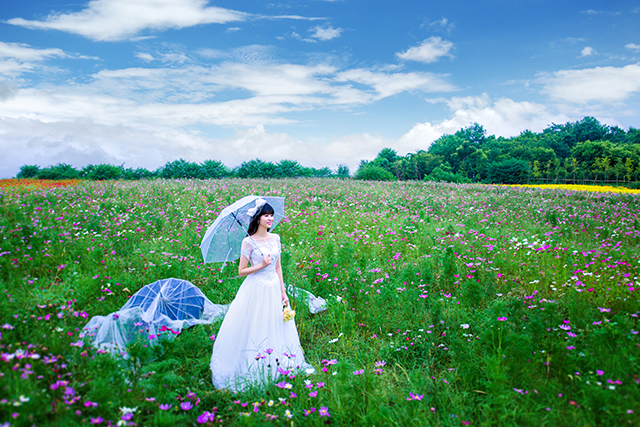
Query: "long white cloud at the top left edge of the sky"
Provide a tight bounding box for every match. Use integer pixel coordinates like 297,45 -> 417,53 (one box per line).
7,0 -> 250,41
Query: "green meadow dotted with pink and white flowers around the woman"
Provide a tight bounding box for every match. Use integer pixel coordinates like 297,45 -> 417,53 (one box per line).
0,179 -> 640,426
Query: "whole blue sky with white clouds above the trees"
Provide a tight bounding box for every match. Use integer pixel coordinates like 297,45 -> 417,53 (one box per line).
0,0 -> 640,177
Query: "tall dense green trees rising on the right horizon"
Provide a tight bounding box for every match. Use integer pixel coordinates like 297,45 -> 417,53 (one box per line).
354,117 -> 640,185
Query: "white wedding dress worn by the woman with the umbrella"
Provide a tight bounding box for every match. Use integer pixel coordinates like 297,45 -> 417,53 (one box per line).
211,234 -> 313,391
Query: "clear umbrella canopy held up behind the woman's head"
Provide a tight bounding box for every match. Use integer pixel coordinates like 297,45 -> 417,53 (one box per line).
200,196 -> 284,263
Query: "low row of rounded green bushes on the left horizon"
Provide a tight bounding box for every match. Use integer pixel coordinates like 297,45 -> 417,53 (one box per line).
17,159 -> 350,181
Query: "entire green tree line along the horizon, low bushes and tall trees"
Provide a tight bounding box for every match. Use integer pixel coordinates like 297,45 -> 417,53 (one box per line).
17,117 -> 640,187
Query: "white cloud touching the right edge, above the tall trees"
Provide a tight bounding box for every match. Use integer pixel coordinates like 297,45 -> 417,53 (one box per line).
539,63 -> 640,104
